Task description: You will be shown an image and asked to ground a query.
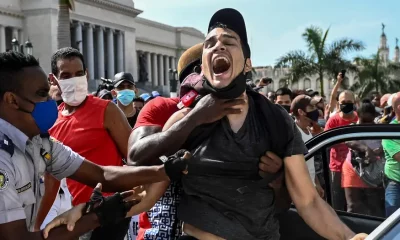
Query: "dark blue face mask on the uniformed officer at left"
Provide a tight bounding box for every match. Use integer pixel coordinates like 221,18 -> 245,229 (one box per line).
19,97 -> 58,134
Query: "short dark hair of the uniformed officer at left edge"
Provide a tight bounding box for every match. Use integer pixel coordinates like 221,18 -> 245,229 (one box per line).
0,51 -> 40,101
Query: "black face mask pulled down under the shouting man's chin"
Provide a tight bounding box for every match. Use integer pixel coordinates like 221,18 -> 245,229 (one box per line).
203,73 -> 247,99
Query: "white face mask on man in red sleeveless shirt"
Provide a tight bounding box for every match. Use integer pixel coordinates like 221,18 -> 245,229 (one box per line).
58,75 -> 88,107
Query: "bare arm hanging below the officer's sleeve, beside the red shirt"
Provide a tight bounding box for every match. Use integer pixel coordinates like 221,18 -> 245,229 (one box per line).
35,172 -> 60,231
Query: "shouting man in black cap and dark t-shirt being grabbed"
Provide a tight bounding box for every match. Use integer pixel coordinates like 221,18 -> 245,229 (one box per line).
130,9 -> 365,240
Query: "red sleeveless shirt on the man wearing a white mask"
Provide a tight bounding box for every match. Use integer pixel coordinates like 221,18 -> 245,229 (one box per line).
49,95 -> 123,206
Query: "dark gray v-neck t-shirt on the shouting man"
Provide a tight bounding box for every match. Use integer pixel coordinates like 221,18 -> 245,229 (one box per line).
178,98 -> 307,239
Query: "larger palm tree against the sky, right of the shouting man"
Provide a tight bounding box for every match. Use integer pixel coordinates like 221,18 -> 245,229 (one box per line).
276,26 -> 365,95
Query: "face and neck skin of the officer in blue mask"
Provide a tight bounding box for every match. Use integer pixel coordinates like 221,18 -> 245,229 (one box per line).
2,67 -> 50,137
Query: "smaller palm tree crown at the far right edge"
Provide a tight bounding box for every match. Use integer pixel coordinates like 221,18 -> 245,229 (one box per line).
350,51 -> 400,98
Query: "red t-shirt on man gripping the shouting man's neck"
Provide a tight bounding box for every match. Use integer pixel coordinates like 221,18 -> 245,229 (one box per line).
134,97 -> 179,240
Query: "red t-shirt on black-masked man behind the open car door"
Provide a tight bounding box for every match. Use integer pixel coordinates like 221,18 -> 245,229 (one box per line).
325,113 -> 358,172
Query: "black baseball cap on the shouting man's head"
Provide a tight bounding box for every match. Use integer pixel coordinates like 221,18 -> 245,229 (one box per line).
208,8 -> 251,58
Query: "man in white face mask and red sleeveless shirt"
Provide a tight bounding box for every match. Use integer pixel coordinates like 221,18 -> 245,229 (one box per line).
45,47 -> 131,240
